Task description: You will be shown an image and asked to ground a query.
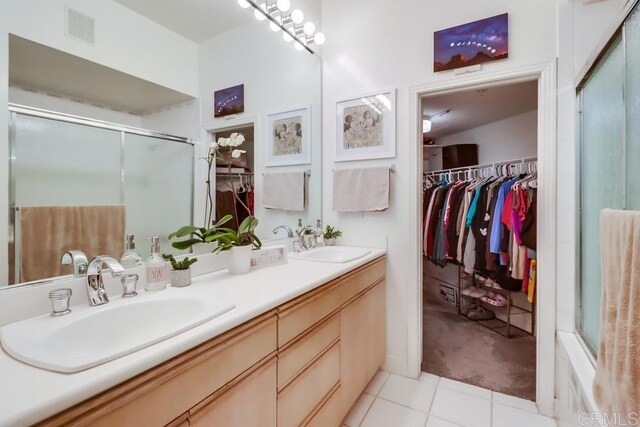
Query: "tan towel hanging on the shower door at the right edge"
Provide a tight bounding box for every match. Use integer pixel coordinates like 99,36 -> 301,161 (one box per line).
593,209 -> 640,425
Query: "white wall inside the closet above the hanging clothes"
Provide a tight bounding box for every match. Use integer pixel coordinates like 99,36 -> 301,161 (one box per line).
437,110 -> 538,164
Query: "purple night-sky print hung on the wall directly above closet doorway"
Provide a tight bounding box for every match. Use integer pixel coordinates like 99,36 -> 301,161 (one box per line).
433,13 -> 509,72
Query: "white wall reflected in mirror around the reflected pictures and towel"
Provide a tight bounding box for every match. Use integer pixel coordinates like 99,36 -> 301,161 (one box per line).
200,22 -> 322,238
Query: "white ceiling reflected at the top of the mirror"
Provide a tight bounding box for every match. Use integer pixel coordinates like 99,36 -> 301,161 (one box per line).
115,0 -> 254,43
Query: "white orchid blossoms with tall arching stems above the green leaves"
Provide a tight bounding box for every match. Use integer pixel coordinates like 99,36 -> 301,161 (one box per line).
205,132 -> 251,227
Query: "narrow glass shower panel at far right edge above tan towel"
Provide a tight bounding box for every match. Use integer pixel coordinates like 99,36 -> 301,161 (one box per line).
624,7 -> 640,211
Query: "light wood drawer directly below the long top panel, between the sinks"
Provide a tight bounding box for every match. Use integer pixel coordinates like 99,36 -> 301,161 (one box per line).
278,313 -> 340,390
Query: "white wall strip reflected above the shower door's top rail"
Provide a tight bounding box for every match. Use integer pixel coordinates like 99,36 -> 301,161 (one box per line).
9,86 -> 142,128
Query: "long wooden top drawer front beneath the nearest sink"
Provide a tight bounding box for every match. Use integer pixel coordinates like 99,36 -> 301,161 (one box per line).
41,313 -> 277,427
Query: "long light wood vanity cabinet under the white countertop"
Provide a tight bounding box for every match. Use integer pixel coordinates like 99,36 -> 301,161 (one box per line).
40,258 -> 386,427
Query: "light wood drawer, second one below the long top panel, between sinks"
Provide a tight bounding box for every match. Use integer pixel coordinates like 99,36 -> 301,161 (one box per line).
278,342 -> 340,427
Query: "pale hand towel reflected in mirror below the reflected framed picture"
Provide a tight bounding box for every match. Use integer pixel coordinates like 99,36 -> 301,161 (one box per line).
262,172 -> 307,211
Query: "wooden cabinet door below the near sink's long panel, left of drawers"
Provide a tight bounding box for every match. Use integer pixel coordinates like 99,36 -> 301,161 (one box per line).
189,357 -> 277,427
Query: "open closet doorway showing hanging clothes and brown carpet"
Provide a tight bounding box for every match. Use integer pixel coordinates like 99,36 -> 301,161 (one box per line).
421,80 -> 539,401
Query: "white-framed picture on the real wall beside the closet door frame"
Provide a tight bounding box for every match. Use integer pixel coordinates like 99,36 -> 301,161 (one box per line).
336,89 -> 396,162
